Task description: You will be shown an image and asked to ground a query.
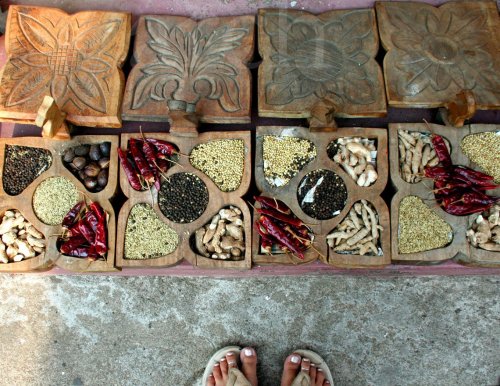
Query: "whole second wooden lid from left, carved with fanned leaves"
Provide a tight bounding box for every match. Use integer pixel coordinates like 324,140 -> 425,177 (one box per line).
123,15 -> 255,122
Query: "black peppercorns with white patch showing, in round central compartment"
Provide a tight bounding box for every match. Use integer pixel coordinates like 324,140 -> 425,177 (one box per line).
297,169 -> 347,220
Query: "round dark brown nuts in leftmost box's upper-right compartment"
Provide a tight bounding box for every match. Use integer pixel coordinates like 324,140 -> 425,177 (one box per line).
62,142 -> 111,192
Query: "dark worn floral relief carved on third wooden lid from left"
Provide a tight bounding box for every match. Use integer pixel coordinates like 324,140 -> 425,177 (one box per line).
263,11 -> 380,105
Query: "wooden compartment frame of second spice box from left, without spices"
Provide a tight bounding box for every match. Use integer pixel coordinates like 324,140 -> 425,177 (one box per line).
117,131 -> 252,269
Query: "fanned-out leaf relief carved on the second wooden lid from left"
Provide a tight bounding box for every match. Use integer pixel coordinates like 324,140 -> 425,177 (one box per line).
131,17 -> 249,112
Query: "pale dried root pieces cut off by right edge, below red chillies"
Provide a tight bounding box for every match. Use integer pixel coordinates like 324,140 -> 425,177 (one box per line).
467,205 -> 500,252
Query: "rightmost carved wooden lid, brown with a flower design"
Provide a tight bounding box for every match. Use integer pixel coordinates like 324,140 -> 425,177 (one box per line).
376,1 -> 500,109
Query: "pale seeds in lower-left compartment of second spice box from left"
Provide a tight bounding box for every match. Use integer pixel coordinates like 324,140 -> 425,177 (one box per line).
124,204 -> 179,260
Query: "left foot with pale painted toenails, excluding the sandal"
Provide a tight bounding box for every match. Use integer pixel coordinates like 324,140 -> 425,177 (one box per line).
207,347 -> 257,386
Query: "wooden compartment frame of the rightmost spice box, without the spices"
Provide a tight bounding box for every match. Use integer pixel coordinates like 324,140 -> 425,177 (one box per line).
389,123 -> 500,266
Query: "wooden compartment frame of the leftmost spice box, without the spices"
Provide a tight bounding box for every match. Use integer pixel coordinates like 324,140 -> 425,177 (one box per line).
0,135 -> 118,272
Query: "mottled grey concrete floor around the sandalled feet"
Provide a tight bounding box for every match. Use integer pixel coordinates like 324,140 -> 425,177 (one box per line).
0,275 -> 500,386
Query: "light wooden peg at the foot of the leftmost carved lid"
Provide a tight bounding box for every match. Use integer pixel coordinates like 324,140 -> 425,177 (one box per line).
35,95 -> 71,140
